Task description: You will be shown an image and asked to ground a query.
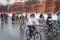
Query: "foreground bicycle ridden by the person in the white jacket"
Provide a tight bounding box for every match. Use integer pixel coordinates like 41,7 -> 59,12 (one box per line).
26,25 -> 42,40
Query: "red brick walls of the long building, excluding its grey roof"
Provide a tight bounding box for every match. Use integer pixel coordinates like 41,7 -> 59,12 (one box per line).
0,0 -> 60,13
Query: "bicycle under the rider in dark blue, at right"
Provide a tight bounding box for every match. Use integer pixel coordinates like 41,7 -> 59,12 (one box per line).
44,24 -> 58,37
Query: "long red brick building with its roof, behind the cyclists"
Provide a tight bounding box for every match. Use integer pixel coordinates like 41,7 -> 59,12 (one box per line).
0,0 -> 60,14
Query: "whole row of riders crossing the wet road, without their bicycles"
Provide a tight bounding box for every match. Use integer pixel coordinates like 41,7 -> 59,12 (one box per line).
0,12 -> 60,39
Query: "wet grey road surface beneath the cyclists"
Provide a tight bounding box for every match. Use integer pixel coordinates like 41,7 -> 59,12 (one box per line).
0,18 -> 60,40
